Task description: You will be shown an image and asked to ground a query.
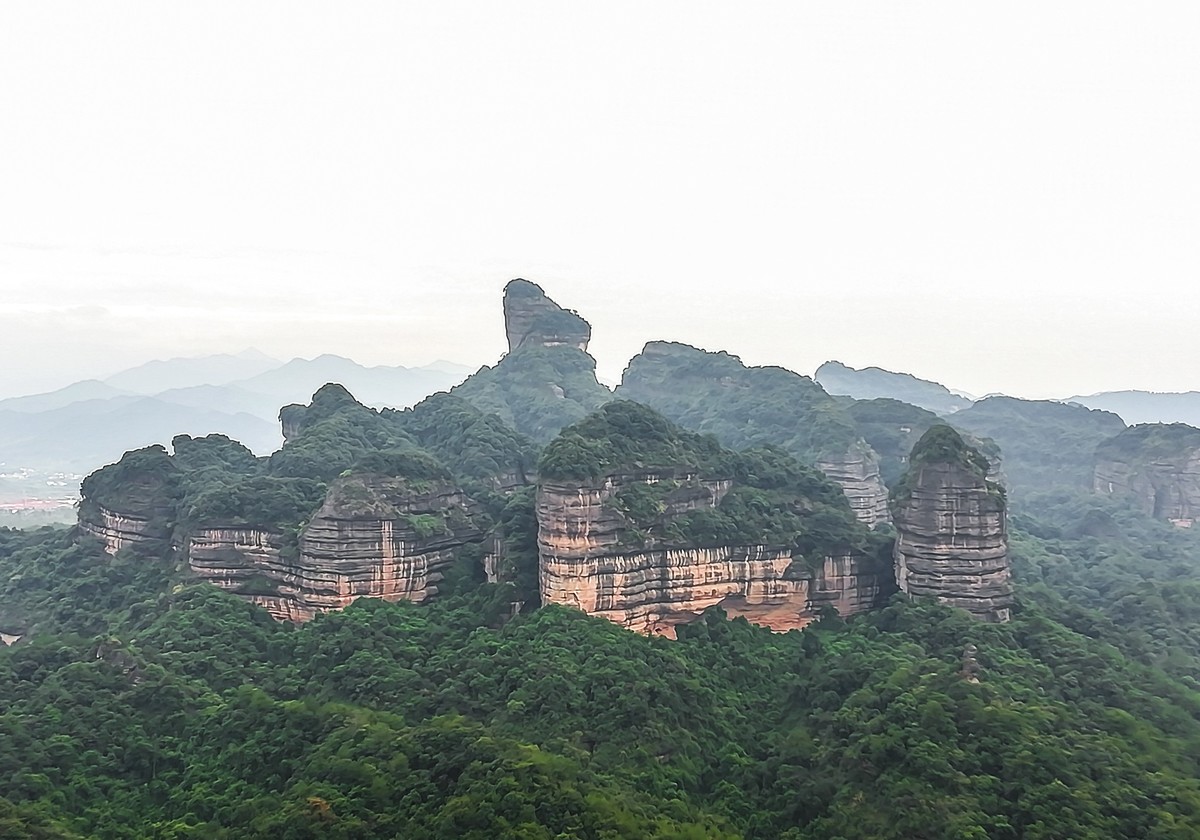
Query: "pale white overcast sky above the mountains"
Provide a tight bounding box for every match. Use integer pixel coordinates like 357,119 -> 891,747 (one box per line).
0,0 -> 1200,398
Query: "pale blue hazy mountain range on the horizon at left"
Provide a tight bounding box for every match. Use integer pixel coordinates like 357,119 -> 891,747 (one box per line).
0,350 -> 474,474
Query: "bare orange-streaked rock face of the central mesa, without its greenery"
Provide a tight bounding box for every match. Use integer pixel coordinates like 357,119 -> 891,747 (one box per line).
538,472 -> 890,636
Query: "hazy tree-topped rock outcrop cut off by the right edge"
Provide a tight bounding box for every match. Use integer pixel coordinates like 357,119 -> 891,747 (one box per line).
1093,424 -> 1200,528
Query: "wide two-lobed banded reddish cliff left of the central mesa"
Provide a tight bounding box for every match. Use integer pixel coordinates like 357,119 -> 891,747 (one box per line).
188,476 -> 484,622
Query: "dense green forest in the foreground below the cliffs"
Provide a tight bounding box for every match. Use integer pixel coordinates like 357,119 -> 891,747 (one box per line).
0,516 -> 1200,840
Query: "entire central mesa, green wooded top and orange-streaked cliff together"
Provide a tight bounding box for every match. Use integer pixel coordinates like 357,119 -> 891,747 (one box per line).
538,401 -> 889,635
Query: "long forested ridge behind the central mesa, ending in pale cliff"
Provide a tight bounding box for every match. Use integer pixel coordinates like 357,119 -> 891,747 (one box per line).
617,341 -> 887,526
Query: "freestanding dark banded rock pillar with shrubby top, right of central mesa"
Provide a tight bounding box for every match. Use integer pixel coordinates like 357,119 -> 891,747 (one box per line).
892,426 -> 1013,622
